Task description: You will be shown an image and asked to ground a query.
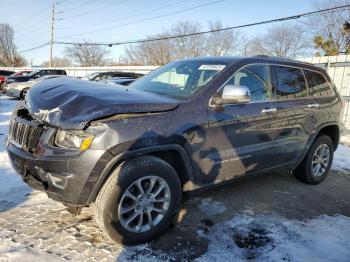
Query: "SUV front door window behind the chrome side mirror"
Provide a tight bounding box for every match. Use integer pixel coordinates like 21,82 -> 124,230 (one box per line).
227,65 -> 272,102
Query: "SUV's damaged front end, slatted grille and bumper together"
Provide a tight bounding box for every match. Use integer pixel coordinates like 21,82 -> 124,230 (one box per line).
6,106 -> 112,206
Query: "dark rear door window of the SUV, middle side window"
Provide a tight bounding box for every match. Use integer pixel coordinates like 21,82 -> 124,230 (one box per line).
271,66 -> 307,99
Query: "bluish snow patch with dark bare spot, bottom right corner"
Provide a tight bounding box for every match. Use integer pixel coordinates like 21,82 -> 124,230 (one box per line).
197,214 -> 350,261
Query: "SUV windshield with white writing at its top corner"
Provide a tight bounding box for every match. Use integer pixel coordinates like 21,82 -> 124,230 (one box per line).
130,61 -> 227,99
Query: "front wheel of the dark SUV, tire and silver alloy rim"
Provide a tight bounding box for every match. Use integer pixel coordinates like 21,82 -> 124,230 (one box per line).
95,156 -> 182,245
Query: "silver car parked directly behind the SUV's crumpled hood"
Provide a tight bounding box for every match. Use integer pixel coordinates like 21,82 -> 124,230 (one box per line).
4,75 -> 62,99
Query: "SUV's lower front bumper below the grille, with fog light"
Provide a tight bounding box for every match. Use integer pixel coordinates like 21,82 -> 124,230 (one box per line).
6,139 -> 112,206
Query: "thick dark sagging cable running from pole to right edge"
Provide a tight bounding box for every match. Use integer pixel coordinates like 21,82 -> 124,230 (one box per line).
55,4 -> 350,46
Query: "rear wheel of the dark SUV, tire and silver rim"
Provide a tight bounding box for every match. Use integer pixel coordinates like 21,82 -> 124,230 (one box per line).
294,135 -> 334,185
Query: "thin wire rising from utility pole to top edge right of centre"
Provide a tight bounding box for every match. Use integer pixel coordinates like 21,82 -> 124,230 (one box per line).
54,0 -> 225,39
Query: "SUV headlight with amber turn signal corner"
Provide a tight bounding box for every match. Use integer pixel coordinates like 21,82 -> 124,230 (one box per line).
55,130 -> 94,151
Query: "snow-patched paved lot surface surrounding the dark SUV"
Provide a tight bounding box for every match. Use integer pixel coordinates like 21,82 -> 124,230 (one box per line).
0,95 -> 350,261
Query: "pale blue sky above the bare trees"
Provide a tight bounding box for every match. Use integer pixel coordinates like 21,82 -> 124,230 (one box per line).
0,0 -> 315,65
